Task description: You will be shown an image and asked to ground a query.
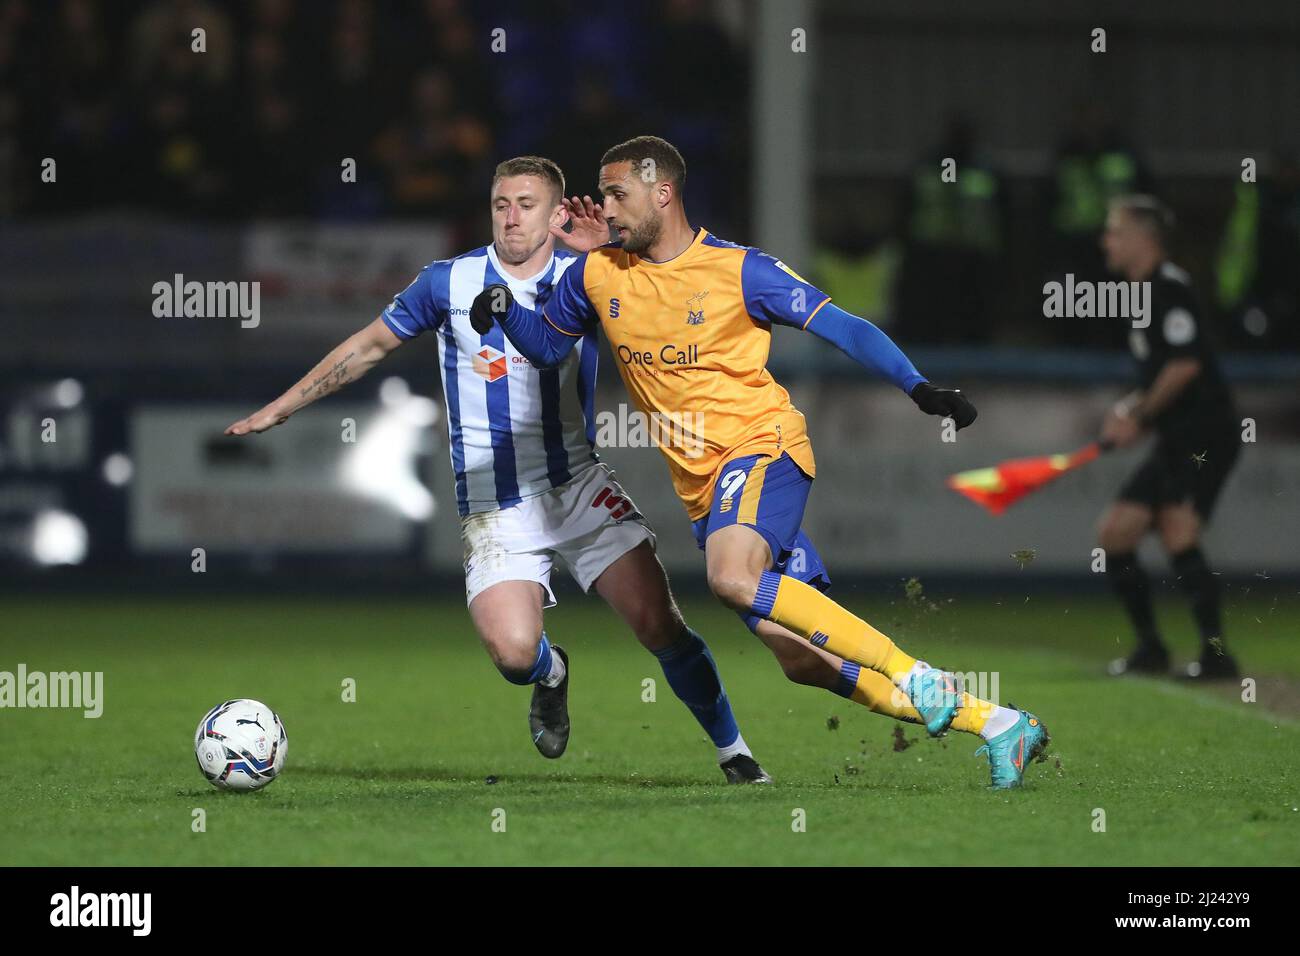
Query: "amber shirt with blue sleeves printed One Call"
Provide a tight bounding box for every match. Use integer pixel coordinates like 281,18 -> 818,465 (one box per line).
542,229 -> 829,520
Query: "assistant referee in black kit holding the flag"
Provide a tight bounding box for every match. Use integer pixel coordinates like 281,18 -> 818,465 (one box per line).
1099,195 -> 1242,679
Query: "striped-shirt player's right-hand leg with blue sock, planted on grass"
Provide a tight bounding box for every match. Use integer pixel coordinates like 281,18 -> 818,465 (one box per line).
594,541 -> 771,783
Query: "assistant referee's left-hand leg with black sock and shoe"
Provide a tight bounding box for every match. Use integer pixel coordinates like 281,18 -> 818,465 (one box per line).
1097,501 -> 1169,676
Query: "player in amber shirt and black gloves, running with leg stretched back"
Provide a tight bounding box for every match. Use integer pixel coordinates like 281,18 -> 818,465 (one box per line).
471,137 -> 1049,788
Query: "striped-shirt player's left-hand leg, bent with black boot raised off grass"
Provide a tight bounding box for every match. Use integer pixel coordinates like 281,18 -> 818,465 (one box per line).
469,581 -> 569,758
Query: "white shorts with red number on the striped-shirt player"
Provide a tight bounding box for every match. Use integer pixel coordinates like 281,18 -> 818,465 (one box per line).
460,462 -> 655,607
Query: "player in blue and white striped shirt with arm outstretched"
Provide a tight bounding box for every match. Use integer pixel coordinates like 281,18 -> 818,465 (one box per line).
226,156 -> 770,783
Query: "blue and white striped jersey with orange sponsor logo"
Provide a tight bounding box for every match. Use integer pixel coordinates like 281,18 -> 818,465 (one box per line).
382,245 -> 597,515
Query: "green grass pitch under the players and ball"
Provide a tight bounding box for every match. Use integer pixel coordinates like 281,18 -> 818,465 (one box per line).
0,588 -> 1300,866
